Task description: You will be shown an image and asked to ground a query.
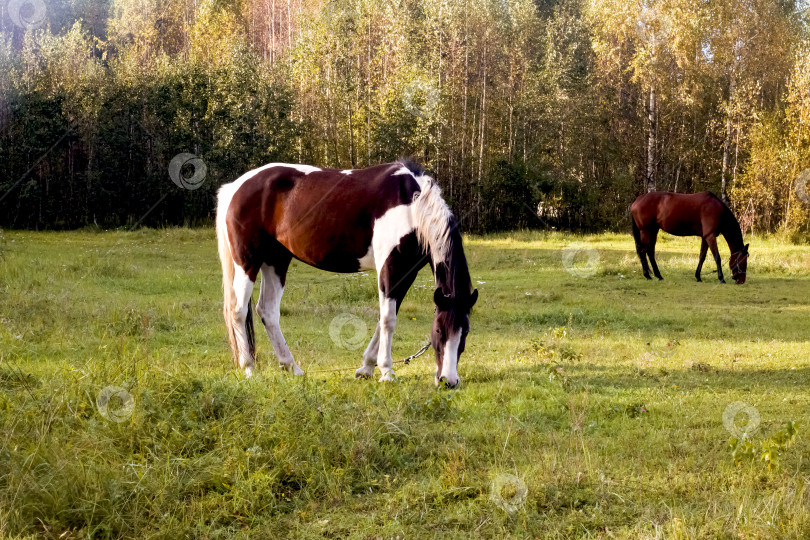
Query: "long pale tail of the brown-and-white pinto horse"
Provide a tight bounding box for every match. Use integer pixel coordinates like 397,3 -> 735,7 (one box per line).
216,185 -> 256,367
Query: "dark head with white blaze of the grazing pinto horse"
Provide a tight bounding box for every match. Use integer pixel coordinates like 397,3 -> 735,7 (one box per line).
430,289 -> 478,388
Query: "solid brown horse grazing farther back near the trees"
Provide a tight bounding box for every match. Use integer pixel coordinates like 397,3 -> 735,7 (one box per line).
630,191 -> 748,285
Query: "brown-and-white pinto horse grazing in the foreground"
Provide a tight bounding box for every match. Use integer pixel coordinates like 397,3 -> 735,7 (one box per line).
216,161 -> 478,388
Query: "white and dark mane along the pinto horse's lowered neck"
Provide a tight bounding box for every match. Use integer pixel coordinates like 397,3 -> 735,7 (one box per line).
397,159 -> 472,295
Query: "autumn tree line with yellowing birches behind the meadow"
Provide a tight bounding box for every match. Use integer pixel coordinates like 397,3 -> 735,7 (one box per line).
0,0 -> 810,237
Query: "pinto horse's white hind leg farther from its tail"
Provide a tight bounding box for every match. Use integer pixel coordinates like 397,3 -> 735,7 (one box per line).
256,256 -> 304,375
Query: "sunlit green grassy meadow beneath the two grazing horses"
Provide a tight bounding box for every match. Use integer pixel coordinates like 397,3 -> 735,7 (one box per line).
0,229 -> 810,539
